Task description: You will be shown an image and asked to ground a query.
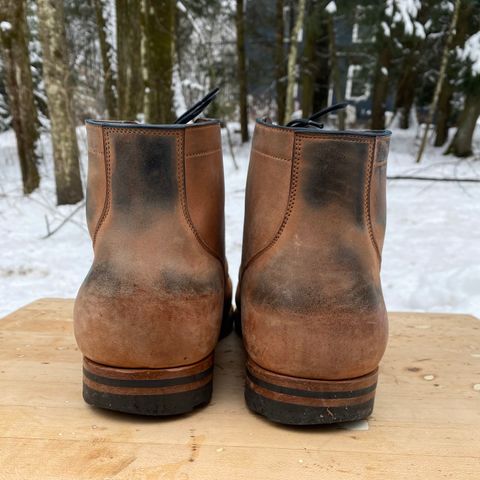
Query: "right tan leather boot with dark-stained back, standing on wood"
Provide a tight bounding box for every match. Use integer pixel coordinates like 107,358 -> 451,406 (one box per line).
237,109 -> 390,425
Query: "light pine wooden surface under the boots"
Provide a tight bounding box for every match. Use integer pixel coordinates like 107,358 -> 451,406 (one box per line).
0,299 -> 480,480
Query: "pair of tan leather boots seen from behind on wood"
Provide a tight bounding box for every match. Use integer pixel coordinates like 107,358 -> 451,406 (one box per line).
74,92 -> 390,425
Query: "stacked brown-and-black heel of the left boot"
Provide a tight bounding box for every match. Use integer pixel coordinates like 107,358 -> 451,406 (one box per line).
83,353 -> 213,416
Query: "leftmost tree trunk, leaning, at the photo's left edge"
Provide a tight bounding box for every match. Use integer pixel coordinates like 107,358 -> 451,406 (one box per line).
0,0 -> 40,194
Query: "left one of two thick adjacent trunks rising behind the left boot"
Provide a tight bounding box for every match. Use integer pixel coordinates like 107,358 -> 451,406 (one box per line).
115,0 -> 144,120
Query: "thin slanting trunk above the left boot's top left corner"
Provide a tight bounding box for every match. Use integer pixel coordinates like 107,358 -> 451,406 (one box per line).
93,0 -> 117,118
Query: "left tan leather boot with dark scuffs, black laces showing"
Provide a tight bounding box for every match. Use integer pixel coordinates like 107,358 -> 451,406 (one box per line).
74,91 -> 231,415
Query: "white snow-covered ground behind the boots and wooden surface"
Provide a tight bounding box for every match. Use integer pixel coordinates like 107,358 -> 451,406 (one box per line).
0,124 -> 480,317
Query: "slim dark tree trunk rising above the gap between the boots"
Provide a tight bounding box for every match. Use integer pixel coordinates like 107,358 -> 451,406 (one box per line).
235,0 -> 249,142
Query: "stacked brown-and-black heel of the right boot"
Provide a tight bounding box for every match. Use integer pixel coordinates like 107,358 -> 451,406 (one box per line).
245,359 -> 378,425
